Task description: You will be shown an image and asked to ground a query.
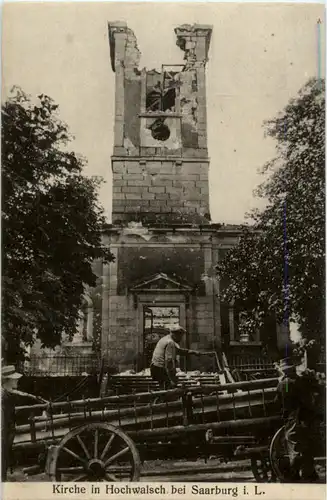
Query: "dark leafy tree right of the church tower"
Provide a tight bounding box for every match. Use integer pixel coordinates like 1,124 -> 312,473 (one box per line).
217,80 -> 325,345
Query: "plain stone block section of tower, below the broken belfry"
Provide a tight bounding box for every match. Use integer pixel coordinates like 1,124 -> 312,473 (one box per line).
112,159 -> 210,224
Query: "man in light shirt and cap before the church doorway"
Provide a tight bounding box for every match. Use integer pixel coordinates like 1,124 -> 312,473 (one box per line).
150,325 -> 211,389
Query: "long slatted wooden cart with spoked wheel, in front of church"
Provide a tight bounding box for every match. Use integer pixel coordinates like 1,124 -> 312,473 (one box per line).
14,378 -> 281,481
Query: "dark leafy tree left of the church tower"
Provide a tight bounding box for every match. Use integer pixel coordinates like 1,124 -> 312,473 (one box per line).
2,88 -> 112,360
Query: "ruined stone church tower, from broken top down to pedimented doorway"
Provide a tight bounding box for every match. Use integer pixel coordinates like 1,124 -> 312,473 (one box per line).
102,22 -> 242,370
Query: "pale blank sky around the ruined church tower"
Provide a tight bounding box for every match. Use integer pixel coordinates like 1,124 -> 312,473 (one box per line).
2,2 -> 324,223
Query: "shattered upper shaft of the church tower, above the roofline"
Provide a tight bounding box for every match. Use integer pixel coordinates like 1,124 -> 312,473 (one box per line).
109,22 -> 212,225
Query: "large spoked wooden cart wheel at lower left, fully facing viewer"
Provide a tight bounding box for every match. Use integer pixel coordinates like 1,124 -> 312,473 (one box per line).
48,423 -> 141,482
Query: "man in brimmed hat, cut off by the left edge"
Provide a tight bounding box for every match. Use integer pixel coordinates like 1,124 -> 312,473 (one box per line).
1,365 -> 22,481
